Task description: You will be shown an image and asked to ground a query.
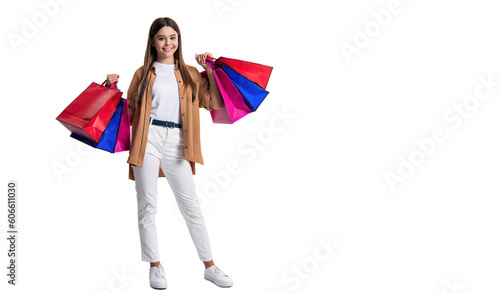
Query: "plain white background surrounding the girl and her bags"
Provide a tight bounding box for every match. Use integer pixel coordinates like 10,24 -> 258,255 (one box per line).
0,0 -> 500,293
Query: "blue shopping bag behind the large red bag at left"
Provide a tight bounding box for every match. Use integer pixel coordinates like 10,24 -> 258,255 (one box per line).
71,98 -> 124,153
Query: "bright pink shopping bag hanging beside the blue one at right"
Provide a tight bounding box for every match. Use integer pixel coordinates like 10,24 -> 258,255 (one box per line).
204,60 -> 252,124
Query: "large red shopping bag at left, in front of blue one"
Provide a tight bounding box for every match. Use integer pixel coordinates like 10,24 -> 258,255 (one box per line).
56,81 -> 123,143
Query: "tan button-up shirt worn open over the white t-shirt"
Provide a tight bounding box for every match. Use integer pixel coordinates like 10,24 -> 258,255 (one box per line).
127,60 -> 213,180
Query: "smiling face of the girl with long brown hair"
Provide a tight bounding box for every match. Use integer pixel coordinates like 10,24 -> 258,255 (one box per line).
152,26 -> 179,64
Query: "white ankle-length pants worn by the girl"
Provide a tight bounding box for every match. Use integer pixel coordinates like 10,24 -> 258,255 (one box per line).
132,124 -> 212,262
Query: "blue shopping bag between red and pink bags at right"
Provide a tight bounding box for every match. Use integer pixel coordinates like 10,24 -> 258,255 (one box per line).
222,64 -> 269,112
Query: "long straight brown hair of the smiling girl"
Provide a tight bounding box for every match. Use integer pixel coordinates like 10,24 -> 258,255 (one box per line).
139,17 -> 193,104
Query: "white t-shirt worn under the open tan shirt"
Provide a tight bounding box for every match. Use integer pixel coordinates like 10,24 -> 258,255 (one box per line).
151,61 -> 181,124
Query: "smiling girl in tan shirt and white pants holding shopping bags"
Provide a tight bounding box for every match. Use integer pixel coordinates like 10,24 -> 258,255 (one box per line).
107,17 -> 233,289
